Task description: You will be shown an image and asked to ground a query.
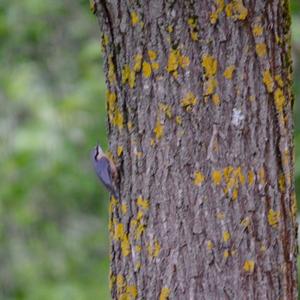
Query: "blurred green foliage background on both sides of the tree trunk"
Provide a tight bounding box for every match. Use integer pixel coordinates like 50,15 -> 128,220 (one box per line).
0,0 -> 300,300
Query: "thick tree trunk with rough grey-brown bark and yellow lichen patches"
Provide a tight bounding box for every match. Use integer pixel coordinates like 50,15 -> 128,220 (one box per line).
94,0 -> 297,300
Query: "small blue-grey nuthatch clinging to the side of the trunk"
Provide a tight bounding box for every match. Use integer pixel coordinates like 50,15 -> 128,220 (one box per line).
93,145 -> 119,199
